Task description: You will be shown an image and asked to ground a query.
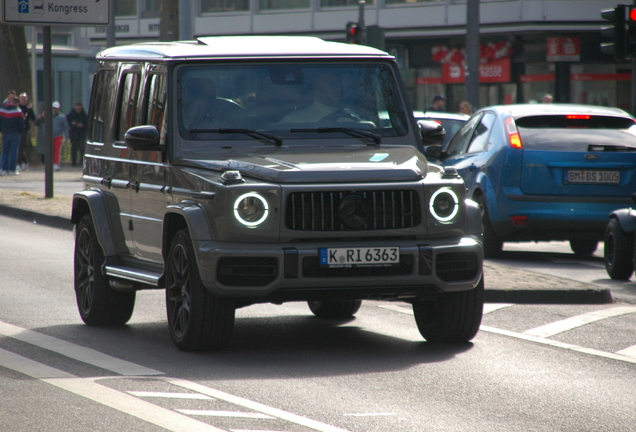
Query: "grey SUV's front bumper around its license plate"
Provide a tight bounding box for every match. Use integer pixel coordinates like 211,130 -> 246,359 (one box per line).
193,237 -> 483,302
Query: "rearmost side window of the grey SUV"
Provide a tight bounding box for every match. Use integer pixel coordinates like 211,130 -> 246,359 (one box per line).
86,69 -> 115,143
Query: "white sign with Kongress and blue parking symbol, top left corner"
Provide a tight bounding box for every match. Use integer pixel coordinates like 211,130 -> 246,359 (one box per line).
2,0 -> 109,26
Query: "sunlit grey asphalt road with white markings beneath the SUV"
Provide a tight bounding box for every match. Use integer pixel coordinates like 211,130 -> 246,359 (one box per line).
0,217 -> 636,432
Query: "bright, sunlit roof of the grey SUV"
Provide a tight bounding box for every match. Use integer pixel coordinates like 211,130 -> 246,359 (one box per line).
97,36 -> 393,60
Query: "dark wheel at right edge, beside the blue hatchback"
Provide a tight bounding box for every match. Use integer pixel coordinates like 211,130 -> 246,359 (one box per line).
605,219 -> 634,280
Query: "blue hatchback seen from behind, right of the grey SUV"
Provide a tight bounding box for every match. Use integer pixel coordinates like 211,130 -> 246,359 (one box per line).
425,104 -> 636,257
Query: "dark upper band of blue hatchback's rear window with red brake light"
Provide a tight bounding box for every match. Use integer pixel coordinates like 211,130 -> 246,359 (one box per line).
515,114 -> 635,129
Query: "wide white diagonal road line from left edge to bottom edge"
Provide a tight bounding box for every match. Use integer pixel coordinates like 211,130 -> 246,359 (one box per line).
0,349 -> 224,432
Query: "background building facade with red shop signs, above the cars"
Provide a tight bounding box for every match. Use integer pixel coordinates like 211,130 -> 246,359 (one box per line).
77,0 -> 631,111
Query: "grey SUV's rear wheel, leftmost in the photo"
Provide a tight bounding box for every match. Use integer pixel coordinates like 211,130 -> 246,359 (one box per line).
74,215 -> 136,326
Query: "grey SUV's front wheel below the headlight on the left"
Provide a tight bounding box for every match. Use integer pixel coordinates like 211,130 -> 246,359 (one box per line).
166,230 -> 235,351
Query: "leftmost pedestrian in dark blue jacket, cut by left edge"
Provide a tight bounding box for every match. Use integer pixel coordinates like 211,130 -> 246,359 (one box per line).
0,96 -> 24,176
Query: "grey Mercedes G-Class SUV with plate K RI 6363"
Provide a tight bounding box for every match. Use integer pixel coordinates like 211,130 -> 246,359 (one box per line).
72,36 -> 484,351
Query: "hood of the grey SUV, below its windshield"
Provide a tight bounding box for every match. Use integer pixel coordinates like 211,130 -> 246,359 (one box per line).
180,146 -> 427,183
